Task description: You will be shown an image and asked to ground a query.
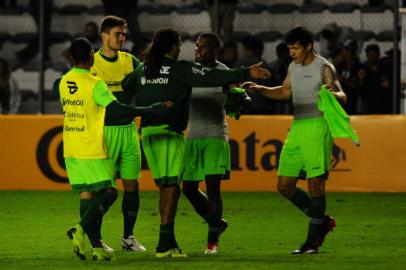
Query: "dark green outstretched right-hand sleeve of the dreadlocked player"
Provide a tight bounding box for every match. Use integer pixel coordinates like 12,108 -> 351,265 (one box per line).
171,61 -> 249,87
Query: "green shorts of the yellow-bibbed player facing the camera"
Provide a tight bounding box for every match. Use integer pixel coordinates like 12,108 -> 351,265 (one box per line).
104,123 -> 141,180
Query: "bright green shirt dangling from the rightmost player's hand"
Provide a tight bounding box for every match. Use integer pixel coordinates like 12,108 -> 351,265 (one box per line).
318,85 -> 360,146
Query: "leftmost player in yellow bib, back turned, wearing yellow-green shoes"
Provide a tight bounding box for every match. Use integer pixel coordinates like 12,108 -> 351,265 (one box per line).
54,38 -> 171,261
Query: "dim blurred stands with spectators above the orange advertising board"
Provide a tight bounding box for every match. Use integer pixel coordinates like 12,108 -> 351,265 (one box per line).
0,0 -> 400,114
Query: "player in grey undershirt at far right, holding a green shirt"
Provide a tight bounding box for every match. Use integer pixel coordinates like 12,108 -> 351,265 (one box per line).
243,27 -> 346,254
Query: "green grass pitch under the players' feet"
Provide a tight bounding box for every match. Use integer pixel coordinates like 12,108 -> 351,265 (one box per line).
0,191 -> 406,270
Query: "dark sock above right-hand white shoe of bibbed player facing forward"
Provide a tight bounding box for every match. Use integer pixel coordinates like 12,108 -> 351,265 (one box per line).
121,190 -> 140,238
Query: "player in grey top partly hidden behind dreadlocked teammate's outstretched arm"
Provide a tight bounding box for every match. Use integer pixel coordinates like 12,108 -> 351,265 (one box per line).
182,32 -> 230,254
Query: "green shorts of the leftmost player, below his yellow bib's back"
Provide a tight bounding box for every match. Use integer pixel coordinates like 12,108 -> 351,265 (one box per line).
65,158 -> 117,192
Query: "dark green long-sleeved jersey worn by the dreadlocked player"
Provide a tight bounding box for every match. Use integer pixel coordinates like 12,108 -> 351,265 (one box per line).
123,57 -> 249,132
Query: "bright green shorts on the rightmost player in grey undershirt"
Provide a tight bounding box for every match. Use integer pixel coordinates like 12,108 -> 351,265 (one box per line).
278,118 -> 333,179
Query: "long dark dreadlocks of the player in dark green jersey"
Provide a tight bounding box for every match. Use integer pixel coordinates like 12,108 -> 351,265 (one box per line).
144,27 -> 179,79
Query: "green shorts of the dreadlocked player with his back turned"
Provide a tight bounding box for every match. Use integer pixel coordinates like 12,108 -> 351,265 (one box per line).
141,125 -> 185,186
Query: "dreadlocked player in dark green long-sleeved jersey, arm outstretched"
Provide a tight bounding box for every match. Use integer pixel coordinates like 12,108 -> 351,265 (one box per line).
123,28 -> 270,257
